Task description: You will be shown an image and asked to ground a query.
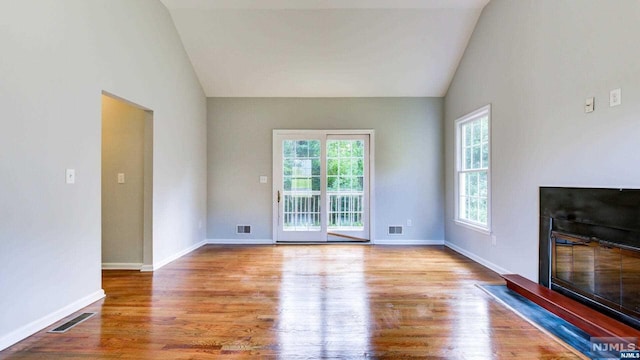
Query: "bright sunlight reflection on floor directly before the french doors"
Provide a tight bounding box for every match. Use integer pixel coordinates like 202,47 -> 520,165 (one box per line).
278,247 -> 370,358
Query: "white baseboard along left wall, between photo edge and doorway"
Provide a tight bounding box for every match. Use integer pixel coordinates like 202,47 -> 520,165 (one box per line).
0,289 -> 105,351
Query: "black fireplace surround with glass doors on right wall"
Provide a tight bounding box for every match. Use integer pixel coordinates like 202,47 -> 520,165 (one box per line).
539,187 -> 640,329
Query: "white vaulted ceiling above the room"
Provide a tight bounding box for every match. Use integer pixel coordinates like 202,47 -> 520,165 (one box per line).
161,0 -> 489,97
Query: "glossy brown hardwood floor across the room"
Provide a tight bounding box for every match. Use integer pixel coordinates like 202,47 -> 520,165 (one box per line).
0,245 -> 578,360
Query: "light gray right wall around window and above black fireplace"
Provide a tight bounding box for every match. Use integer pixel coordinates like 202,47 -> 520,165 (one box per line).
445,0 -> 640,280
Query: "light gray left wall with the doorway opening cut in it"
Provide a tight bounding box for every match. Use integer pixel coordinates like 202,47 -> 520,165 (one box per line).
0,0 -> 206,349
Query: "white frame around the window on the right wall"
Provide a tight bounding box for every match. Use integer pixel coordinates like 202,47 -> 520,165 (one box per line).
454,104 -> 492,235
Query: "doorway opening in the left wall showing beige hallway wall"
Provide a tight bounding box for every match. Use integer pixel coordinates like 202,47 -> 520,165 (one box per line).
101,92 -> 153,271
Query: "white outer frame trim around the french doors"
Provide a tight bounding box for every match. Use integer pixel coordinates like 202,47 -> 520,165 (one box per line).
271,129 -> 375,244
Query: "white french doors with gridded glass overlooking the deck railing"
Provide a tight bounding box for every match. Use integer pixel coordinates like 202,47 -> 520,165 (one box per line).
273,130 -> 372,242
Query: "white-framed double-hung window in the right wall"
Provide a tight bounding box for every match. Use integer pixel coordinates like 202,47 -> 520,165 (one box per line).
455,105 -> 491,231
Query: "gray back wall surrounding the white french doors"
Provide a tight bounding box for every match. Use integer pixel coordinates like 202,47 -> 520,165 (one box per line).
207,98 -> 444,240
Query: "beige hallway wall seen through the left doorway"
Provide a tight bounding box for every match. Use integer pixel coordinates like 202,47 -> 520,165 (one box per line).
102,96 -> 147,266
